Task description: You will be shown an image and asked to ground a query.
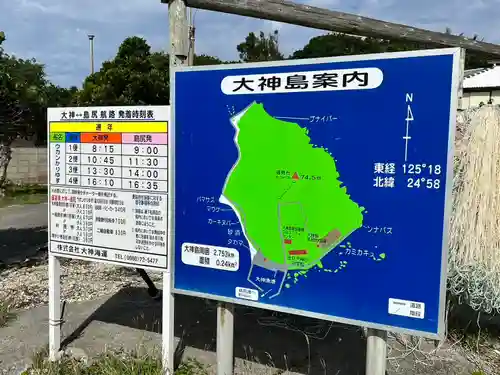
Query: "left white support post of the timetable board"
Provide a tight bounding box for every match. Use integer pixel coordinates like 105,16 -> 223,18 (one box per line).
49,251 -> 61,361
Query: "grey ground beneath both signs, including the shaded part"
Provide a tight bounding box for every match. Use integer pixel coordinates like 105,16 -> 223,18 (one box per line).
0,288 -> 473,375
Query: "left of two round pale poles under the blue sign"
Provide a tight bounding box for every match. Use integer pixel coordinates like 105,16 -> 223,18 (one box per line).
217,302 -> 234,375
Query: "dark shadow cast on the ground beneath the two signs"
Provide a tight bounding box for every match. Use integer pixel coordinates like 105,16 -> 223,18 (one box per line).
62,288 -> 366,375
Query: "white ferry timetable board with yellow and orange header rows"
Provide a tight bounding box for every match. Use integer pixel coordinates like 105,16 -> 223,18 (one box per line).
48,106 -> 170,269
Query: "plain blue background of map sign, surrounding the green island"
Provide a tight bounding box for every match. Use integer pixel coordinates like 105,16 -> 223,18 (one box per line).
172,51 -> 454,335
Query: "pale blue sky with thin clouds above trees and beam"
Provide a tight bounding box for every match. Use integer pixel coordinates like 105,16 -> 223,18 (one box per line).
0,0 -> 500,87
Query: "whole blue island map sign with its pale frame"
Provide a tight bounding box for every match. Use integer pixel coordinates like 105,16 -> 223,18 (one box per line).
170,49 -> 461,337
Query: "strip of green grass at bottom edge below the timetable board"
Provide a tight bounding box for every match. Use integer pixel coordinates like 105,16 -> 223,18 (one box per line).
22,348 -> 208,375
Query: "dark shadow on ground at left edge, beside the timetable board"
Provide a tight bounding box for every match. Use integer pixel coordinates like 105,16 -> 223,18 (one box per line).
0,226 -> 47,269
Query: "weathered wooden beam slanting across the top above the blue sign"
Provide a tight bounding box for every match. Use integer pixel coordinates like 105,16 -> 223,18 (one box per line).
182,0 -> 500,56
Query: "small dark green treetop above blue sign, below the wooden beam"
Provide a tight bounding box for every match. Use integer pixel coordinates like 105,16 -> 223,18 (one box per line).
236,30 -> 284,62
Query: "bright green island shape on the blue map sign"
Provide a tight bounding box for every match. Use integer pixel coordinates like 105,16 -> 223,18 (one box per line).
219,102 -> 364,295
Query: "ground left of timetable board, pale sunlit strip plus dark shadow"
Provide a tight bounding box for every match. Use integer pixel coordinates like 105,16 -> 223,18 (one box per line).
0,203 -> 48,264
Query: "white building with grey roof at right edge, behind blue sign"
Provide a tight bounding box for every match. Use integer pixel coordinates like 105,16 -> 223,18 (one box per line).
461,63 -> 500,109
